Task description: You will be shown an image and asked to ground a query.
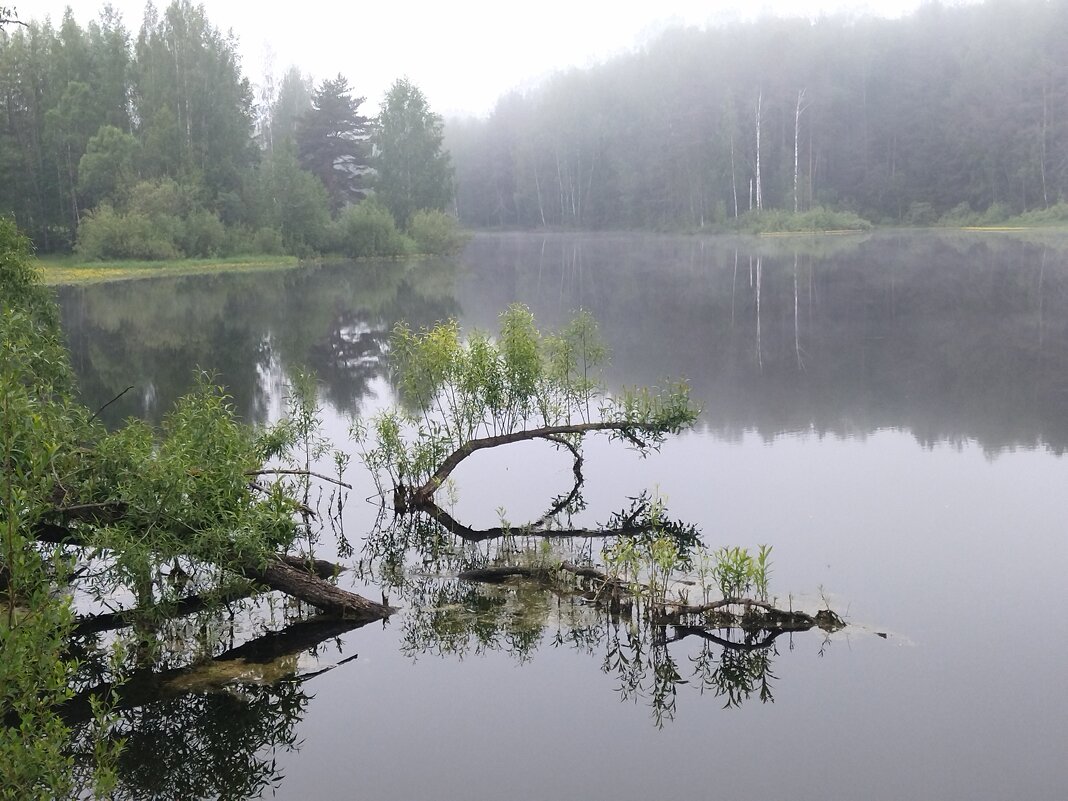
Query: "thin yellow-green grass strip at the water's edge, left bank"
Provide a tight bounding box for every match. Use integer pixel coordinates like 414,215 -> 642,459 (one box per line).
35,255 -> 298,286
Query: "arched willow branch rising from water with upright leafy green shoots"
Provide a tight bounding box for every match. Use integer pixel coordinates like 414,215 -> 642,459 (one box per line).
352,304 -> 697,513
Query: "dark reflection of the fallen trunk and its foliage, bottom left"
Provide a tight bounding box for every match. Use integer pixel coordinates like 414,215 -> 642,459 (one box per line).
61,618 -> 371,801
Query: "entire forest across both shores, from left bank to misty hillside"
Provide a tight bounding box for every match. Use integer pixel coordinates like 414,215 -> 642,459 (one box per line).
8,0 -> 1068,247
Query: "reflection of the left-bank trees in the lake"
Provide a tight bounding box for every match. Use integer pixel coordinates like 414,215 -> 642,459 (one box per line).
60,260 -> 458,424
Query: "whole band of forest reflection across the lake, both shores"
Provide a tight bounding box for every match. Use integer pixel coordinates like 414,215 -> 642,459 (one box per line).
61,232 -> 1068,453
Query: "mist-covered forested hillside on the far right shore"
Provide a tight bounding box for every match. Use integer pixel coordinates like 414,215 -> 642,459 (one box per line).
449,0 -> 1068,229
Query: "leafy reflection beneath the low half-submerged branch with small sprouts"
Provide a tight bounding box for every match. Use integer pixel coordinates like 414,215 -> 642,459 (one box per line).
388,566 -> 826,726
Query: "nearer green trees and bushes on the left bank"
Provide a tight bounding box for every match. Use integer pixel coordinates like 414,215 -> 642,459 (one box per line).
0,0 -> 457,260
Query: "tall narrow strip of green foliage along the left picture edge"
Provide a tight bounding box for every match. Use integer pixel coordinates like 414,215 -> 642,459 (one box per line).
0,219 -> 121,799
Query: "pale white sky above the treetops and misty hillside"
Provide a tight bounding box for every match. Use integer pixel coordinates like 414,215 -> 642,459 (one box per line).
29,0 -> 956,116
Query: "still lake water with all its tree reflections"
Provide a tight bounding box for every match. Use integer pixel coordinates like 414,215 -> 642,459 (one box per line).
61,233 -> 1068,801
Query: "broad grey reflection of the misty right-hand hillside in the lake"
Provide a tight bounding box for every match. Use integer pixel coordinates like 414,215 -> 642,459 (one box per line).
460,233 -> 1068,453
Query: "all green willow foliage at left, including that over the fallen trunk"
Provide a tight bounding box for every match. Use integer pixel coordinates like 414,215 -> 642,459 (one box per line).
0,219 -> 322,799
